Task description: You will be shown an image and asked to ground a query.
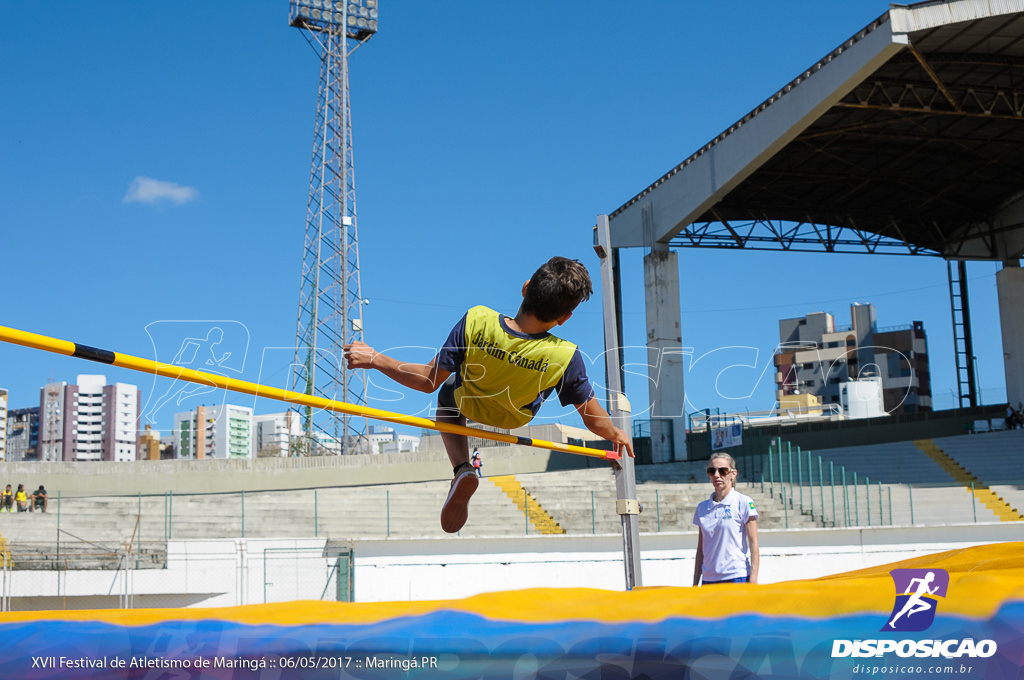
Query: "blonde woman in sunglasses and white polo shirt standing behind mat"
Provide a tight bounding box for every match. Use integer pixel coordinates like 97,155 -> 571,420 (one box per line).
693,453 -> 761,586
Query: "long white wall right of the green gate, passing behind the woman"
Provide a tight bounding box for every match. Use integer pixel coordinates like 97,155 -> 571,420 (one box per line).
355,522 -> 1020,602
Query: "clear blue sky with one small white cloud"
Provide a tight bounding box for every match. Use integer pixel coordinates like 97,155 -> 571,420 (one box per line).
0,0 -> 1005,440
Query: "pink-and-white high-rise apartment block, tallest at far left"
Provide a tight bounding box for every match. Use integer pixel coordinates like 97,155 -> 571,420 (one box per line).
39,375 -> 140,462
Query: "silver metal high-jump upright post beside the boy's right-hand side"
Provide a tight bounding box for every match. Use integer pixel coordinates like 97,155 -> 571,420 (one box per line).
594,215 -> 643,590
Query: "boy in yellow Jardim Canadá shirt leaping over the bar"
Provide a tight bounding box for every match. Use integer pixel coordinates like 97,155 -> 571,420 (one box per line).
344,257 -> 633,534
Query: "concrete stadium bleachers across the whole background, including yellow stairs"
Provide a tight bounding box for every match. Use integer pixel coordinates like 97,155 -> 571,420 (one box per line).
0,430 -> 1024,568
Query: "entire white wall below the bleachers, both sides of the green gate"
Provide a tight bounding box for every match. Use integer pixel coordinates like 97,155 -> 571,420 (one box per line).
5,522 -> 1020,609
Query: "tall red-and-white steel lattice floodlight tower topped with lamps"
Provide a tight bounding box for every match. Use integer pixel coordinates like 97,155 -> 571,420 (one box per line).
289,0 -> 377,455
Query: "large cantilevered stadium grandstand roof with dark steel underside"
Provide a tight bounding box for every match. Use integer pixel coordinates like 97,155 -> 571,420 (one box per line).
609,0 -> 1024,260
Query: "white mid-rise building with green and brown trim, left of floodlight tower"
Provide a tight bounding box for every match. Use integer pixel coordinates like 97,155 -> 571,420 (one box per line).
171,403 -> 253,459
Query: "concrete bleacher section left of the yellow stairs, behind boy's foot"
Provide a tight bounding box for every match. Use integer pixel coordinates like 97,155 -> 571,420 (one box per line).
0,480 -> 526,553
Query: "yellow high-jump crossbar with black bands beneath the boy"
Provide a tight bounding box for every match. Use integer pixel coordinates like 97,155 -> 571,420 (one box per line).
0,326 -> 621,460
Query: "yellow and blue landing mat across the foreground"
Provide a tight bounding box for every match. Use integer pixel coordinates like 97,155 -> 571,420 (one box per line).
0,543 -> 1024,680
